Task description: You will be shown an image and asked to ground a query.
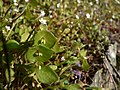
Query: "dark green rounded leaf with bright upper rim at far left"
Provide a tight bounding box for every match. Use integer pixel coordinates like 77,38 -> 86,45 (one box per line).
6,40 -> 20,50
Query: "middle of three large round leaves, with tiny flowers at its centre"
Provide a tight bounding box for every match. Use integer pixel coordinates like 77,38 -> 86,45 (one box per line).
26,45 -> 53,62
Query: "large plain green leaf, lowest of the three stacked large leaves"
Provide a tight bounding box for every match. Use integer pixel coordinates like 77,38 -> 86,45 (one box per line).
36,66 -> 58,84
